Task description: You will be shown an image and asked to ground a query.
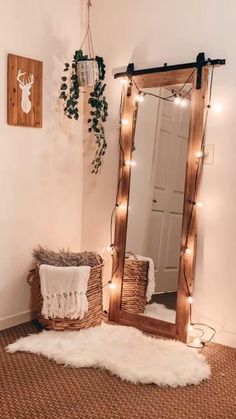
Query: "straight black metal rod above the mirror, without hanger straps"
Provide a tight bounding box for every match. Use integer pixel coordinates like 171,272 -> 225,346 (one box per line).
114,53 -> 225,79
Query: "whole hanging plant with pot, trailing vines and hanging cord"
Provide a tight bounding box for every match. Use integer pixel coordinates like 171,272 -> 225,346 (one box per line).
60,1 -> 108,173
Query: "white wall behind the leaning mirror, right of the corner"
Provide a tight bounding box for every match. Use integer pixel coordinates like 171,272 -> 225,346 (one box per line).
82,0 -> 236,345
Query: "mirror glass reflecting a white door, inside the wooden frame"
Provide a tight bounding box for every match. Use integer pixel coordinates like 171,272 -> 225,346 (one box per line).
121,84 -> 191,323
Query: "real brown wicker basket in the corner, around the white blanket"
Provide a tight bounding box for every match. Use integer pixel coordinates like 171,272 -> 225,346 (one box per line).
30,263 -> 103,330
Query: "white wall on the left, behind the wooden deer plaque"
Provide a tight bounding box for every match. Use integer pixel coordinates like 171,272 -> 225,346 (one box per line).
0,0 -> 83,328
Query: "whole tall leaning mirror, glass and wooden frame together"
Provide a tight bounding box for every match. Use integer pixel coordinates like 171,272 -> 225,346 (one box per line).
109,63 -> 208,341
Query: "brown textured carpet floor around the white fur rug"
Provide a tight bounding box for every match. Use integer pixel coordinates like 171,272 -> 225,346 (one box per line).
0,322 -> 236,419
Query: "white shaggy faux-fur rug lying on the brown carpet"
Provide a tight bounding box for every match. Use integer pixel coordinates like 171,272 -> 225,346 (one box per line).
7,324 -> 210,387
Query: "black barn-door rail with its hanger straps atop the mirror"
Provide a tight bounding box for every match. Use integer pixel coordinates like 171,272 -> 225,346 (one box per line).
114,52 -> 225,93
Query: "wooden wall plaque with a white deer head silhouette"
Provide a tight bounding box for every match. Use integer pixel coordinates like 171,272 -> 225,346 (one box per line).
7,54 -> 43,128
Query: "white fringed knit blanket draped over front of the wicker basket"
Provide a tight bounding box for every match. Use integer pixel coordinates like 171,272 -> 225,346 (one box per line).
39,265 -> 91,319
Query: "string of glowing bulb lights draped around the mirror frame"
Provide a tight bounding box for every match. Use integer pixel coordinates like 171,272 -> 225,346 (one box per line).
104,65 -> 221,348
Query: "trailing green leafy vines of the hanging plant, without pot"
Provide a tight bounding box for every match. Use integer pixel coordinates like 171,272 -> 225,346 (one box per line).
60,49 -> 108,173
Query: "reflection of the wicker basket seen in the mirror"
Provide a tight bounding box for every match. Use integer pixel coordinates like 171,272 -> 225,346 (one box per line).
121,257 -> 149,314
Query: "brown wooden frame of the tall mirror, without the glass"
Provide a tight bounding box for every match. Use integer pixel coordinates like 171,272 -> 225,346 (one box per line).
109,67 -> 208,342
